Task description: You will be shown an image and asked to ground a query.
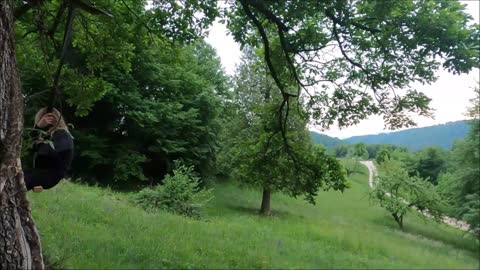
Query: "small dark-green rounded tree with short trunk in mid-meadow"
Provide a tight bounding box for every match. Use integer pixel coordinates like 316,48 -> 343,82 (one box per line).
234,124 -> 347,215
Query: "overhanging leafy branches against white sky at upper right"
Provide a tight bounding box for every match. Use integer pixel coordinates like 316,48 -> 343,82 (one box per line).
226,0 -> 480,128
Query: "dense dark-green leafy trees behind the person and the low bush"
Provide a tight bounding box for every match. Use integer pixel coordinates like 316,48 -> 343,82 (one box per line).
17,0 -> 227,185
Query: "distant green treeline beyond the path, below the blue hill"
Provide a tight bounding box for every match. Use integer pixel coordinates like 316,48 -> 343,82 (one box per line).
328,117 -> 480,234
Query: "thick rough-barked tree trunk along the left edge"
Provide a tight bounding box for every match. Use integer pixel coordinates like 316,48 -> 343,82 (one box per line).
0,0 -> 44,269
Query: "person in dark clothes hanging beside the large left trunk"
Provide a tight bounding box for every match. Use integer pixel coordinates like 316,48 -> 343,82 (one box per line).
25,108 -> 73,191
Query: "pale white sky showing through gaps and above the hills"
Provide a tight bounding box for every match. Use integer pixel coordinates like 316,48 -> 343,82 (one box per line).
207,0 -> 480,139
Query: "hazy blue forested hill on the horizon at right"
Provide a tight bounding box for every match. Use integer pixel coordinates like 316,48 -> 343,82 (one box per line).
344,121 -> 470,151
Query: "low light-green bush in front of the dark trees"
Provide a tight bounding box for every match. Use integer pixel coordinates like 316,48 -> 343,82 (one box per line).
134,162 -> 213,218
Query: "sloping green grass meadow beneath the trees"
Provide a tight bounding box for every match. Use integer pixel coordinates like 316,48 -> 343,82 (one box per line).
29,161 -> 479,269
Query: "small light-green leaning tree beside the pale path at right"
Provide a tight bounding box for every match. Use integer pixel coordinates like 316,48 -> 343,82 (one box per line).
370,161 -> 442,229
